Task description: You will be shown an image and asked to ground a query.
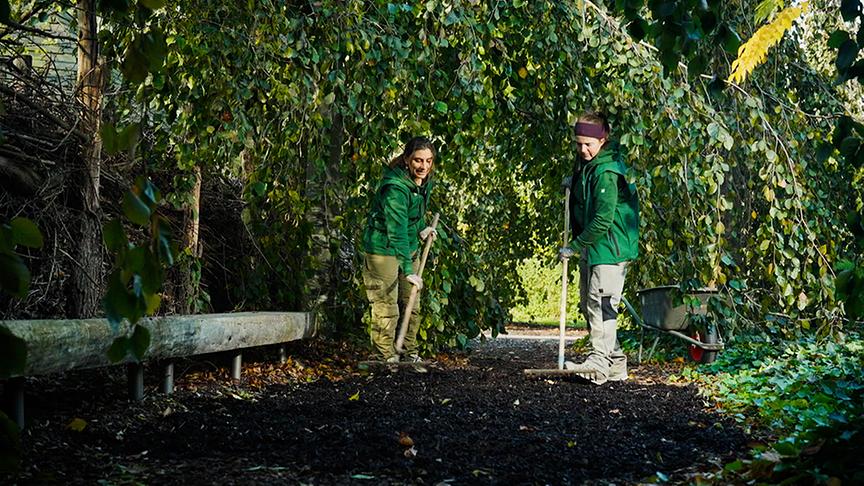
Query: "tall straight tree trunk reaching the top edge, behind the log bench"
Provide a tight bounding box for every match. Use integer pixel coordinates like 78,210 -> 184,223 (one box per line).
71,0 -> 103,317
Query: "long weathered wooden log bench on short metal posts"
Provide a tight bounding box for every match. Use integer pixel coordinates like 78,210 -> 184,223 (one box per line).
0,312 -> 316,426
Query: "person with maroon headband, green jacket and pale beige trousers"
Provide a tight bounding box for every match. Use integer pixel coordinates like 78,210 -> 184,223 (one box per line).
559,113 -> 639,385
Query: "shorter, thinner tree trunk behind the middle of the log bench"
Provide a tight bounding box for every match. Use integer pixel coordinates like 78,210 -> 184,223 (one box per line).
177,166 -> 201,314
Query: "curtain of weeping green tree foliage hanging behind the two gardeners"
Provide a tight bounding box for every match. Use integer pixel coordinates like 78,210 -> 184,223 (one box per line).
4,0 -> 857,345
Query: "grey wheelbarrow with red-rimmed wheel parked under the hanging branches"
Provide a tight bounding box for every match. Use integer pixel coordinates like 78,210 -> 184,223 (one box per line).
621,285 -> 725,363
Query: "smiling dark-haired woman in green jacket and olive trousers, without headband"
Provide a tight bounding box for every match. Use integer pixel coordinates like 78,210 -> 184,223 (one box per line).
363,137 -> 436,364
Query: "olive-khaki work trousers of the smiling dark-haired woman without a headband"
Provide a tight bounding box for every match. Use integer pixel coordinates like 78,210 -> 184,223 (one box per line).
363,253 -> 420,360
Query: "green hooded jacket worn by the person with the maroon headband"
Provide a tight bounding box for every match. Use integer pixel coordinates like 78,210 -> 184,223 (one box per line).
570,141 -> 639,266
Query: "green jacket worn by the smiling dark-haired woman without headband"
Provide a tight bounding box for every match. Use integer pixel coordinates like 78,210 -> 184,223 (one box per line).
363,167 -> 432,275
